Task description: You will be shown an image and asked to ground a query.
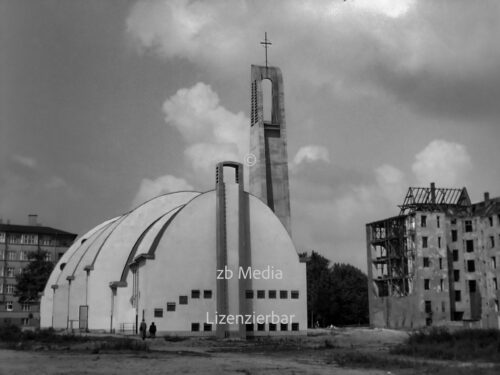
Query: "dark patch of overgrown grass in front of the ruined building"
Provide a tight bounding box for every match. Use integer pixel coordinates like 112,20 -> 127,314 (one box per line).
391,327 -> 500,363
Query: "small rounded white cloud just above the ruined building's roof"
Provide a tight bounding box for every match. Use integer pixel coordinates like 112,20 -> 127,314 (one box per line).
412,140 -> 472,187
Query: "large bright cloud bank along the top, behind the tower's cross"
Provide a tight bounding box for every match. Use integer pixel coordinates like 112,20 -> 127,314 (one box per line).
127,0 -> 500,117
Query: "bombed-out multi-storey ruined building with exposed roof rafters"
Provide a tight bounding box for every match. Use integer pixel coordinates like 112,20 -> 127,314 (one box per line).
366,183 -> 500,328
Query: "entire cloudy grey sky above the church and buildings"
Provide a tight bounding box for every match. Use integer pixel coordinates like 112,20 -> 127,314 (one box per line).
0,0 -> 500,271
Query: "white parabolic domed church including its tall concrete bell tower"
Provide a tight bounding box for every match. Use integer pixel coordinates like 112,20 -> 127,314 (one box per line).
41,65 -> 307,338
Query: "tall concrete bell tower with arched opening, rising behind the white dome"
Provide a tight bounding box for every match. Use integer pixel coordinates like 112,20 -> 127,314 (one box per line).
250,64 -> 291,235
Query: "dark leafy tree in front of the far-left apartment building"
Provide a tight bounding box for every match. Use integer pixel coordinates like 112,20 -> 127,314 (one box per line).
15,250 -> 54,302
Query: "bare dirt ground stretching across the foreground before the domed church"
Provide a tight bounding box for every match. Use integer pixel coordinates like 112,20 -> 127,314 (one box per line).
0,328 -> 407,375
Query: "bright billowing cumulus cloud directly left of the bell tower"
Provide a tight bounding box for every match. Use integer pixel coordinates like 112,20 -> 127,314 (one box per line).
163,82 -> 250,173
